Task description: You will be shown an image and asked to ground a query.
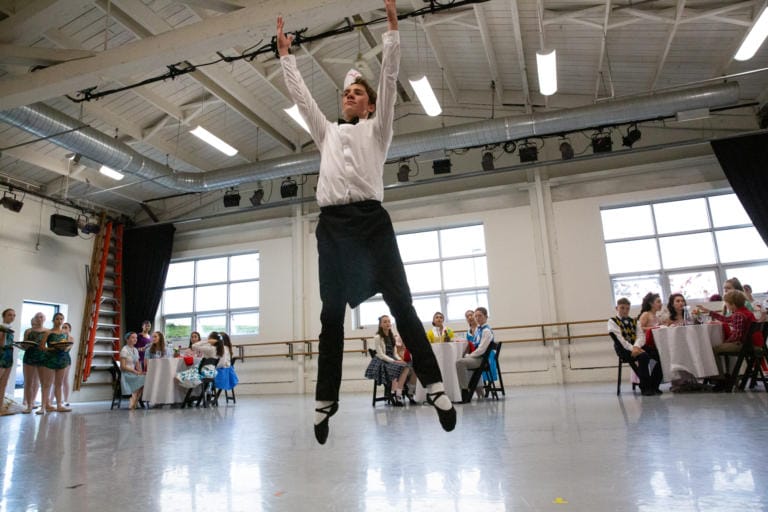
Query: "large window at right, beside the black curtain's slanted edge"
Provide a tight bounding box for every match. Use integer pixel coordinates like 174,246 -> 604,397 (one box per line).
600,194 -> 768,304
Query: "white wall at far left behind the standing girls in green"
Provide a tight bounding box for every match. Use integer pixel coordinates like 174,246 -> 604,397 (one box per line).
0,196 -> 93,395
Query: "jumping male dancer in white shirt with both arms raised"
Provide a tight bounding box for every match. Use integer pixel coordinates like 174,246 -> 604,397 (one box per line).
277,0 -> 456,444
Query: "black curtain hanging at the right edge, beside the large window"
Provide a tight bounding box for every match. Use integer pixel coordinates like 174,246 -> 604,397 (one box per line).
711,133 -> 768,245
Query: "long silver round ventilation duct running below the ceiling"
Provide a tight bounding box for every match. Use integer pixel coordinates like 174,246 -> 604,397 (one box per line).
0,82 -> 739,192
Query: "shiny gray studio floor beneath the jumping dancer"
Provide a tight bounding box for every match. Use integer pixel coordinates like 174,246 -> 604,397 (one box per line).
0,383 -> 768,512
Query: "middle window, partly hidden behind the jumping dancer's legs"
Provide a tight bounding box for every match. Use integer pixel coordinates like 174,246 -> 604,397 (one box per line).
354,224 -> 488,327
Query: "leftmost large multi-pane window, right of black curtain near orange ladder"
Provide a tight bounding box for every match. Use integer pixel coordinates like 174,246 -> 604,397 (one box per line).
162,252 -> 260,342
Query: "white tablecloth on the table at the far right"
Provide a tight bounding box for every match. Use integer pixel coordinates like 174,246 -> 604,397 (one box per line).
653,323 -> 723,381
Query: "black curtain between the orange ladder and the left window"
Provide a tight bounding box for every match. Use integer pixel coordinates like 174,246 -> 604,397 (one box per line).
123,224 -> 176,333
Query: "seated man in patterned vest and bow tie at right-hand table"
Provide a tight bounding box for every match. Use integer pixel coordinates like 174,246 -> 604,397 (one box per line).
608,298 -> 661,396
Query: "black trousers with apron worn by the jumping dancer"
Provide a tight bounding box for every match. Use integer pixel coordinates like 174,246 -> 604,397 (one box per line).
315,201 -> 443,401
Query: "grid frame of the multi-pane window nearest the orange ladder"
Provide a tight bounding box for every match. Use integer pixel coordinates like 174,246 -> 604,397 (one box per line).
160,251 -> 261,341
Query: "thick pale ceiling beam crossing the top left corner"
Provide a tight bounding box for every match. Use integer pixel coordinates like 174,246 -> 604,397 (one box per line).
0,0 -> 381,110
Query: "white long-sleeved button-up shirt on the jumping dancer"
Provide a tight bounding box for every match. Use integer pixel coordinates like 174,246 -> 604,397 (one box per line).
280,30 -> 400,206
